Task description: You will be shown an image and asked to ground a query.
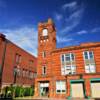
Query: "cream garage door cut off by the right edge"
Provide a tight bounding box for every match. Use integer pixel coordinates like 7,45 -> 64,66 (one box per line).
91,81 -> 100,98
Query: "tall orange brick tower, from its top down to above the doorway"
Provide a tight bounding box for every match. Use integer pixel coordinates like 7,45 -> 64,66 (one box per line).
37,19 -> 56,77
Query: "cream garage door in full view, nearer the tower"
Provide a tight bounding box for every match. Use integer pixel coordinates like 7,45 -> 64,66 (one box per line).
71,82 -> 85,98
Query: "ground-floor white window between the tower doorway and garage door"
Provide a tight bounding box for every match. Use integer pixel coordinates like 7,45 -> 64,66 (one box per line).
56,81 -> 66,94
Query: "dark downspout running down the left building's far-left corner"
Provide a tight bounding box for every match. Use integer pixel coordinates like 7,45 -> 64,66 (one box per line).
0,36 -> 7,92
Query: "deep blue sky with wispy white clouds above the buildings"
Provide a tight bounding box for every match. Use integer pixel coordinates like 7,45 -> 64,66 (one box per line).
0,0 -> 100,56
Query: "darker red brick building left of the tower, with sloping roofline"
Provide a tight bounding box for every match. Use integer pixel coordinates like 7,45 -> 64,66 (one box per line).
0,34 -> 37,87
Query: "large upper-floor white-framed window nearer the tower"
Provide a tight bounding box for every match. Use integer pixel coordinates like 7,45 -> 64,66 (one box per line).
61,53 -> 76,75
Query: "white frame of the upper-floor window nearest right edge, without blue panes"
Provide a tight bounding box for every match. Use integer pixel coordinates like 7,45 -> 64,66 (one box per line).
83,51 -> 96,73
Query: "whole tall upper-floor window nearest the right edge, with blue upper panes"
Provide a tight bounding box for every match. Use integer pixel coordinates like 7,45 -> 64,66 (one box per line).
83,51 -> 95,73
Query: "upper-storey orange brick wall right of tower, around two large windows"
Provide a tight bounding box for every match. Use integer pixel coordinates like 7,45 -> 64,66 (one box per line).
52,43 -> 100,76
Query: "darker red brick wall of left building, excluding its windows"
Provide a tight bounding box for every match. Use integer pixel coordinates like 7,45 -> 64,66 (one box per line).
0,33 -> 37,85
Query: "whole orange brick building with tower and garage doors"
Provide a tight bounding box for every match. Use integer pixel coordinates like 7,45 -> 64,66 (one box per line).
35,19 -> 100,98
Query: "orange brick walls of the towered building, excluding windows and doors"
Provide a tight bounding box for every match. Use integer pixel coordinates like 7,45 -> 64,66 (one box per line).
35,19 -> 100,98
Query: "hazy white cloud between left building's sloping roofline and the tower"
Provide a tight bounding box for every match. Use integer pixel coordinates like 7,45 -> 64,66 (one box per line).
0,27 -> 37,56
